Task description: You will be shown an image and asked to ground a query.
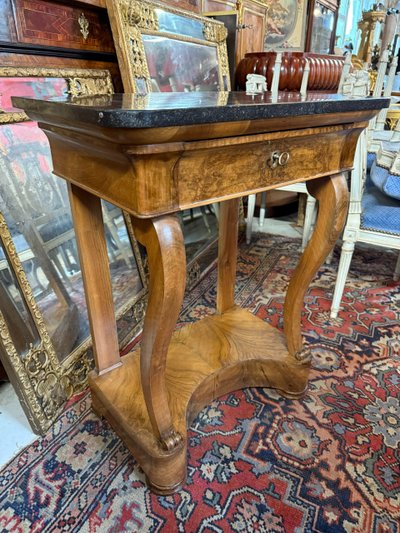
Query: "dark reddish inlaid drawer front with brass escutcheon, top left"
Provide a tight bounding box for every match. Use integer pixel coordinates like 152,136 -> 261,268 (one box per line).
13,0 -> 114,52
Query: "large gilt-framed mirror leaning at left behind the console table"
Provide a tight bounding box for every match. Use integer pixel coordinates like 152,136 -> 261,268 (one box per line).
0,67 -> 146,433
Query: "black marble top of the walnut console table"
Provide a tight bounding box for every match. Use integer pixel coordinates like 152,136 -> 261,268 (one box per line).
12,92 -> 390,128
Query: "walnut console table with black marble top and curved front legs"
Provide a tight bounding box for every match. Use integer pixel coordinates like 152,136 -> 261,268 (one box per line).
14,92 -> 389,494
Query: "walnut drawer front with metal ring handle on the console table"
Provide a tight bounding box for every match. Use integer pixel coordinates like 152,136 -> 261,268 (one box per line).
174,130 -> 360,208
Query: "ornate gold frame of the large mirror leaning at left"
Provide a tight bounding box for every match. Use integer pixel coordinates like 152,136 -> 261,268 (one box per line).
0,67 -> 147,433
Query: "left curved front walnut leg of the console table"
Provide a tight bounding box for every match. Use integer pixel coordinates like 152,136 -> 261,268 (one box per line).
132,214 -> 186,451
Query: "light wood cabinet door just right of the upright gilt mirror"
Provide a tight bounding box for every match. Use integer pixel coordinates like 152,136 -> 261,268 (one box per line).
236,2 -> 266,64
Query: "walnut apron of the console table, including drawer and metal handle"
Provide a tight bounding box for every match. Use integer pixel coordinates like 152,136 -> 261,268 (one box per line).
47,123 -> 365,218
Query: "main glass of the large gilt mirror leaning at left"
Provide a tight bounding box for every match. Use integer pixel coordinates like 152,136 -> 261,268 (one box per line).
0,122 -> 143,361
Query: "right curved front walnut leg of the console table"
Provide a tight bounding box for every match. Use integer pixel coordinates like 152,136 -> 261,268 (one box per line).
284,174 -> 349,361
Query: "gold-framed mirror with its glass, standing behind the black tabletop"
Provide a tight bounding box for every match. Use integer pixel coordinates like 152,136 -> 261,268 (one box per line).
107,0 -> 230,266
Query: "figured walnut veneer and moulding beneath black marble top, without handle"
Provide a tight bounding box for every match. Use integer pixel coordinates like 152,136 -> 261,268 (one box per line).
42,111 -> 373,217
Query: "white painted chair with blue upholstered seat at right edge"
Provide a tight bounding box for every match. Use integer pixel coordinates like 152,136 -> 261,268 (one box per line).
331,53 -> 400,318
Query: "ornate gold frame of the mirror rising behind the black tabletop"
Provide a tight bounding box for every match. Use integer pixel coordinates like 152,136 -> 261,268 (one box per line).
107,0 -> 230,93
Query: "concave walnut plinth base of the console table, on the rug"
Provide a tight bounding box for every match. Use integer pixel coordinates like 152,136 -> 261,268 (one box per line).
89,307 -> 309,494
